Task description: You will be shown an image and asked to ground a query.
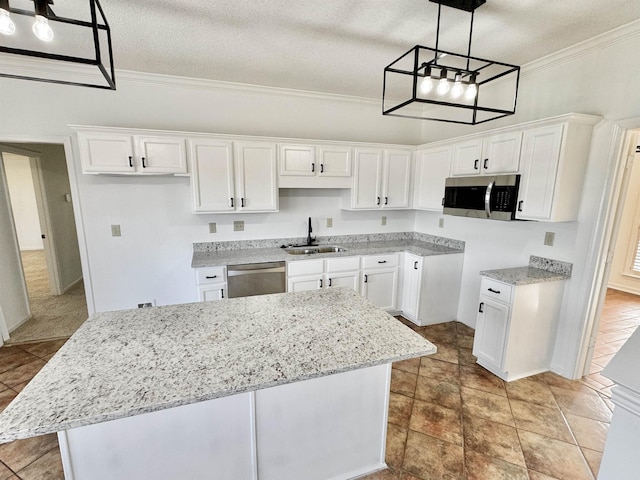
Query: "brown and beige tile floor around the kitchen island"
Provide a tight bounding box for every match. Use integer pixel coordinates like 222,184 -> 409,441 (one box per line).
0,291 -> 640,480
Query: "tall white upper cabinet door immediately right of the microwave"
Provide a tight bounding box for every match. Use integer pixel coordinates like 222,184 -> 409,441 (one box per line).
516,125 -> 564,220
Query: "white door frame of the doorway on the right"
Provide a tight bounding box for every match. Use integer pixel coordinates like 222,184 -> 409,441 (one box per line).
573,117 -> 640,379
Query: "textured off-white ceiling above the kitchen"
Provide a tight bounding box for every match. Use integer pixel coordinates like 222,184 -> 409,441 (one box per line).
54,0 -> 640,98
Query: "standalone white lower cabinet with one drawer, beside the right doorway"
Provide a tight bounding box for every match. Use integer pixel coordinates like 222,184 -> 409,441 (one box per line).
473,277 -> 564,381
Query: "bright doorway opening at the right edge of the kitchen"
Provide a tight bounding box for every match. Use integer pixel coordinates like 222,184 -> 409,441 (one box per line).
583,129 -> 640,386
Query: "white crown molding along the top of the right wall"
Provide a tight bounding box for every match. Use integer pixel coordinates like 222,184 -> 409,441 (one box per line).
520,20 -> 640,74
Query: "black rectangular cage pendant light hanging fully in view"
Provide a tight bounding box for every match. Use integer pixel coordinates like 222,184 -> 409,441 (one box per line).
382,0 -> 520,125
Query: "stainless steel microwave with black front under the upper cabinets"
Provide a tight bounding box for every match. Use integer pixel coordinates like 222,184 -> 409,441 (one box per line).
443,175 -> 520,220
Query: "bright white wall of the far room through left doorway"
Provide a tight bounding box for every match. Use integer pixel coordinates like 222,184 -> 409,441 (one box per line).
2,153 -> 44,250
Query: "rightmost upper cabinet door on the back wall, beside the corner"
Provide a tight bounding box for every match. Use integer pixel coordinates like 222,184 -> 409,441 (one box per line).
382,150 -> 411,208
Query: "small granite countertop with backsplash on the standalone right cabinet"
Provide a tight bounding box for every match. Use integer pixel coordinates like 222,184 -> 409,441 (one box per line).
480,255 -> 573,286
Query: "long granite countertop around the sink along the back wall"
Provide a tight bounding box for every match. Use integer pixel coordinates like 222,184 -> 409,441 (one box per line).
191,240 -> 464,268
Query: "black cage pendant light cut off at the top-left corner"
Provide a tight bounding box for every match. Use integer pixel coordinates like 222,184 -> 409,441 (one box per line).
0,0 -> 116,90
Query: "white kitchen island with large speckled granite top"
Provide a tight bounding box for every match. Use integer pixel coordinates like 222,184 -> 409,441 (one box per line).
0,288 -> 435,480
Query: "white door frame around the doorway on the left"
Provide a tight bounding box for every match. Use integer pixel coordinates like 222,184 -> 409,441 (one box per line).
0,134 -> 95,315
